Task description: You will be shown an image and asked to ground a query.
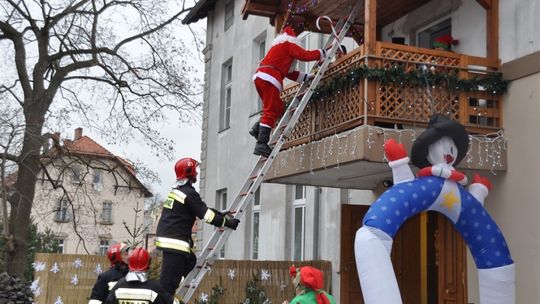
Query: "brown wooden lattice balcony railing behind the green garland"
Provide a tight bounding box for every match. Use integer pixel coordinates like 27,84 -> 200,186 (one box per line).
282,42 -> 502,148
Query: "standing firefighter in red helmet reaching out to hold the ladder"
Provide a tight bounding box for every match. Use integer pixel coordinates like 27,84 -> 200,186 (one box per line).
156,158 -> 240,294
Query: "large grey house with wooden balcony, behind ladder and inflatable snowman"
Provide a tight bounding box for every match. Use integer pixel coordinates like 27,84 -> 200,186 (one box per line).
184,0 -> 540,304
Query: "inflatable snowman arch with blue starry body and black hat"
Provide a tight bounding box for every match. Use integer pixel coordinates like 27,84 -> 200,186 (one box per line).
355,114 -> 515,304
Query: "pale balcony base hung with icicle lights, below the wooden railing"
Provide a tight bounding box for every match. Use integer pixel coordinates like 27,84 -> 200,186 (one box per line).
266,126 -> 506,190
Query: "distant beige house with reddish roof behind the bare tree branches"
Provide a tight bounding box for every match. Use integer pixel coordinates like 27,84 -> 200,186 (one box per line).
32,128 -> 152,255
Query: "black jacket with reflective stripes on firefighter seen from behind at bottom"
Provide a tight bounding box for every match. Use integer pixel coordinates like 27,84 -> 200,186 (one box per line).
105,272 -> 178,304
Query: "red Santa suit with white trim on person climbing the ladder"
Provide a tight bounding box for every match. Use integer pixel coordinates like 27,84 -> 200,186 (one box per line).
253,28 -> 325,128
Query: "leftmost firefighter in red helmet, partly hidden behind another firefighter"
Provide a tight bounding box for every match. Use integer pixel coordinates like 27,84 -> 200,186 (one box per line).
88,243 -> 129,304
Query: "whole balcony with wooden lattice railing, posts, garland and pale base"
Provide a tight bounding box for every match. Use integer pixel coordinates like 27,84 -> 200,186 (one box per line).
244,0 -> 506,189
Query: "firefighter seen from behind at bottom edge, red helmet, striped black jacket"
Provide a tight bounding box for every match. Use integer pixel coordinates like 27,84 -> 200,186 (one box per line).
105,247 -> 178,304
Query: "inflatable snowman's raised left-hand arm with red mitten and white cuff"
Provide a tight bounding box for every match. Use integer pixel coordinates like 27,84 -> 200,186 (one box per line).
384,139 -> 414,184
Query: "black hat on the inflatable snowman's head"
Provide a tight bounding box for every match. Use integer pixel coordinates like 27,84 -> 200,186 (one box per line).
411,114 -> 469,168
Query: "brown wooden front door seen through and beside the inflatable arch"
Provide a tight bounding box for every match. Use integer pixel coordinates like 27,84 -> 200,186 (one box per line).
340,205 -> 467,304
